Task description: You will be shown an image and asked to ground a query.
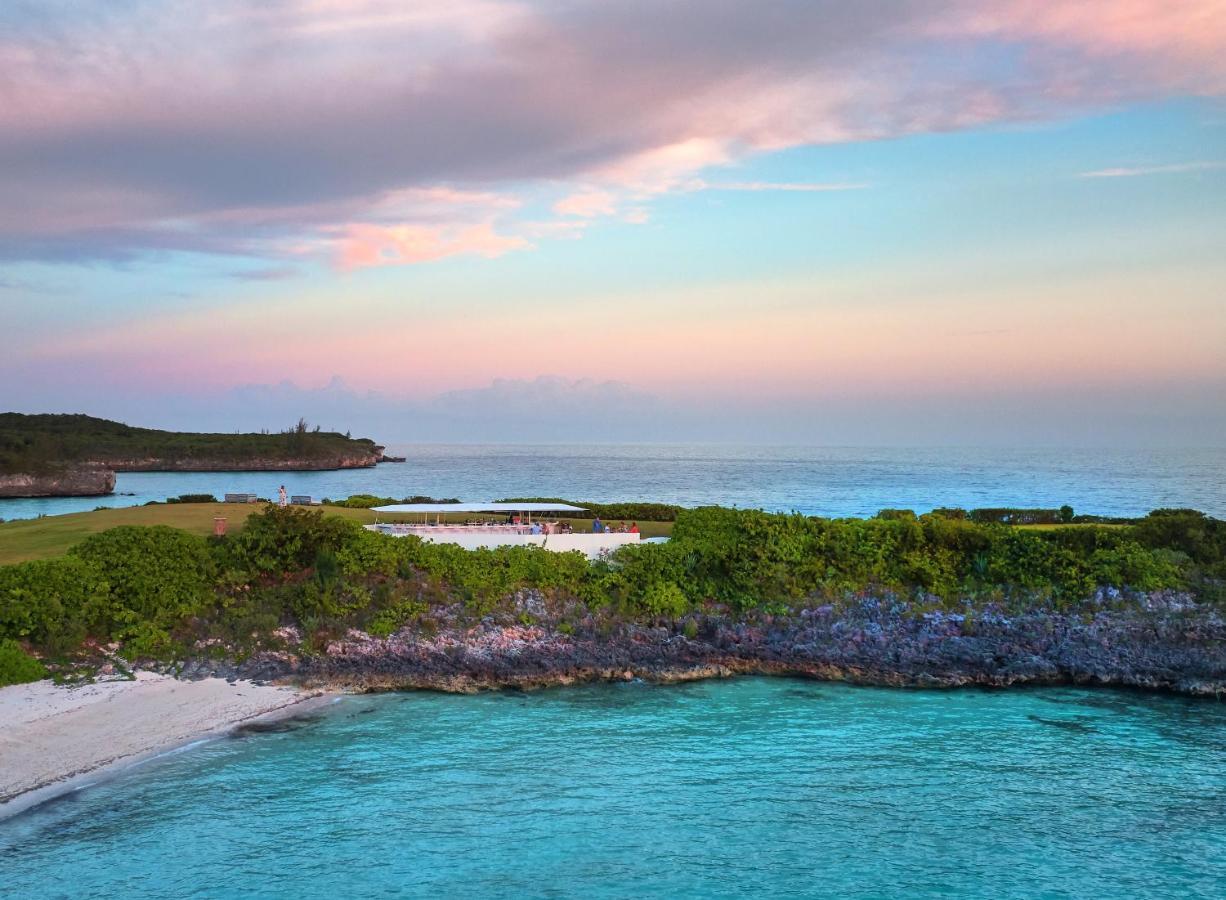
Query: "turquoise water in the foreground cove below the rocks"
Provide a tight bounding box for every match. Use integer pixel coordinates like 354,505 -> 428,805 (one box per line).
0,678 -> 1226,898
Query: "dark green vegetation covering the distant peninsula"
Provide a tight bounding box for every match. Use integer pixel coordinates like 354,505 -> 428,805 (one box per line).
0,412 -> 375,473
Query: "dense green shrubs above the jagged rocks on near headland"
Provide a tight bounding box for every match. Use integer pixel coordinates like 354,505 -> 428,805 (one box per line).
0,508 -> 1226,658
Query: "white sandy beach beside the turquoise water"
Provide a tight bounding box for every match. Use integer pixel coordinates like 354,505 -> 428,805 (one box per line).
0,672 -> 318,817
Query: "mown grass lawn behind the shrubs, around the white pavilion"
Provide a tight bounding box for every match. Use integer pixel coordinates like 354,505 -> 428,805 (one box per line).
0,503 -> 673,565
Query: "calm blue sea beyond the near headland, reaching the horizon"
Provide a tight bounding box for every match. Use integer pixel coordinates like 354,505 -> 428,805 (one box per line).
0,444 -> 1226,519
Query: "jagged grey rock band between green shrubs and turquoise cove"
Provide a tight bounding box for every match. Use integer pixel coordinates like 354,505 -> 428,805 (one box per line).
189,595 -> 1226,696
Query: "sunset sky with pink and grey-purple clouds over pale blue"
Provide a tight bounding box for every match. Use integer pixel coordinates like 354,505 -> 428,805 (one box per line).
0,0 -> 1226,446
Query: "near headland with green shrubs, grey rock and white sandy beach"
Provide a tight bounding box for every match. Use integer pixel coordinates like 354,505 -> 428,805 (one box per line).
0,498 -> 1226,819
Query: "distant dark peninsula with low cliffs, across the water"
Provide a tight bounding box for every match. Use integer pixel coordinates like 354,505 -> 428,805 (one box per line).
0,412 -> 384,497
